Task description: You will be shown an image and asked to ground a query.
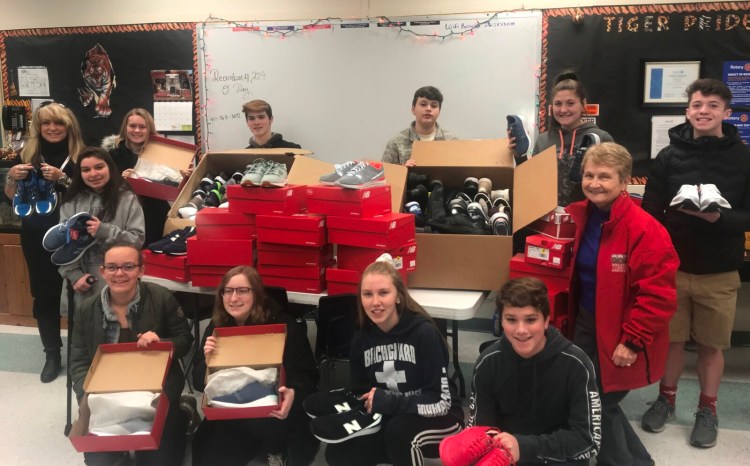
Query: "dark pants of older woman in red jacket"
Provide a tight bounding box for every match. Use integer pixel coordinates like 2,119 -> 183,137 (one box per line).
573,309 -> 652,466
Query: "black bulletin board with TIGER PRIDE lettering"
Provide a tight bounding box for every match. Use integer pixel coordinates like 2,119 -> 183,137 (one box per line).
539,2 -> 750,175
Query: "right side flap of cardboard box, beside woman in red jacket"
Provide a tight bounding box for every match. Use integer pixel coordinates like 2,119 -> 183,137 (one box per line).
513,147 -> 557,233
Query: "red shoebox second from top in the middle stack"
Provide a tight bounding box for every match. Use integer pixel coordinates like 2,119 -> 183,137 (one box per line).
255,214 -> 326,246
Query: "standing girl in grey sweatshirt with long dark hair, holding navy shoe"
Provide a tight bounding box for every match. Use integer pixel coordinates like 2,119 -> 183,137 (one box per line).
59,147 -> 145,320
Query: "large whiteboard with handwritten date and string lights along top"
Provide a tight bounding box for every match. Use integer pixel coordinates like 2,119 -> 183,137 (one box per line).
198,11 -> 541,163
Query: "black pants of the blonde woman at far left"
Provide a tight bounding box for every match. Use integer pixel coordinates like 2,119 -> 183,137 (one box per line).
21,224 -> 63,356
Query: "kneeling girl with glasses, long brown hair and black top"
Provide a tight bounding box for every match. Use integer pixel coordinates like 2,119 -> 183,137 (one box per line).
193,266 -> 317,466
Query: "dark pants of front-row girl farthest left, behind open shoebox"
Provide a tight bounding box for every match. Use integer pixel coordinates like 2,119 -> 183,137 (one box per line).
83,399 -> 188,466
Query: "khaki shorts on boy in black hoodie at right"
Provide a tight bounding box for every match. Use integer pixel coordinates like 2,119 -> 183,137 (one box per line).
669,271 -> 740,350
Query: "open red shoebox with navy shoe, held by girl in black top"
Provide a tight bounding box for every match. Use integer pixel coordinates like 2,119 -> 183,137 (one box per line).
201,324 -> 286,421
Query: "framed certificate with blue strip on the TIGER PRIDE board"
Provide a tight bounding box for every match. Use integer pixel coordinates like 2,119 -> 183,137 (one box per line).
642,60 -> 701,107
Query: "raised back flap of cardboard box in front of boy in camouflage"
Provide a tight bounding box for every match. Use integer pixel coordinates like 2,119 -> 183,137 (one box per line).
411,139 -> 513,167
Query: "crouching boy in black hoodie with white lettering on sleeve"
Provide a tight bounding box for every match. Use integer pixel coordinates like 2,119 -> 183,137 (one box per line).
464,278 -> 601,466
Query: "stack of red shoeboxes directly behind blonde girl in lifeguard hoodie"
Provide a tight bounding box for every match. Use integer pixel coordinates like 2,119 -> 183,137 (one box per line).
306,185 -> 417,295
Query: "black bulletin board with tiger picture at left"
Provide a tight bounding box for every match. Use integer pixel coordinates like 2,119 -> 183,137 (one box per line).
0,23 -> 199,146
